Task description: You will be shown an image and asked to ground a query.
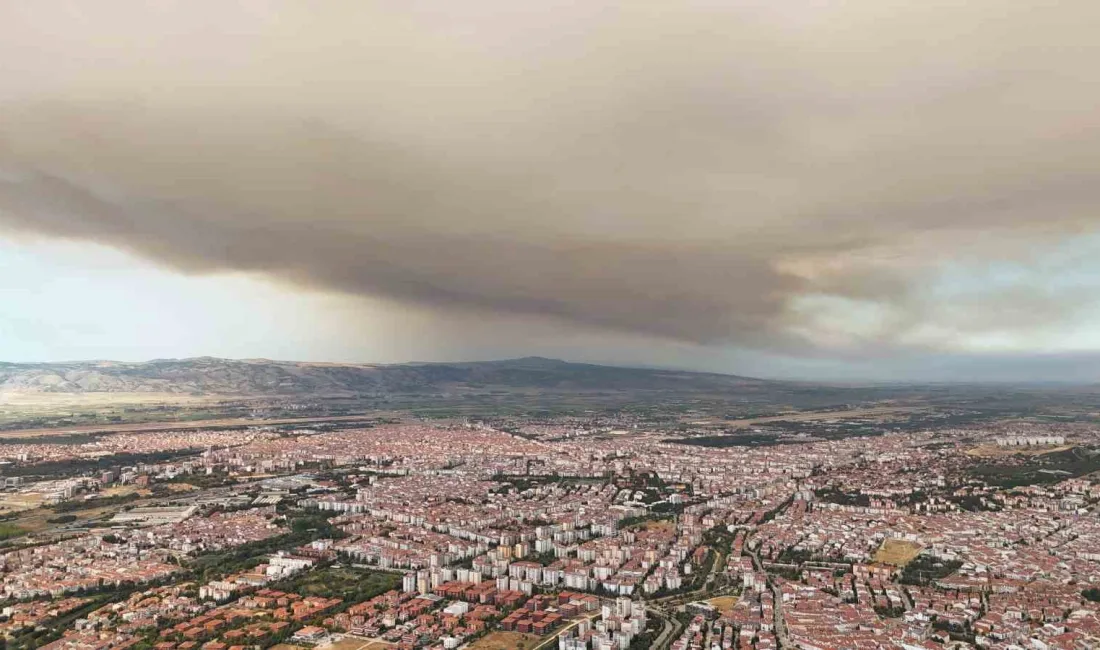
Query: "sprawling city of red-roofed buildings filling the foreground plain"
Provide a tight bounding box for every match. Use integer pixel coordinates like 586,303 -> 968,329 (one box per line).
0,389 -> 1100,650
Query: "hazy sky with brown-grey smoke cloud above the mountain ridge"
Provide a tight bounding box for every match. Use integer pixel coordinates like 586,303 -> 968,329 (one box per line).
0,0 -> 1100,382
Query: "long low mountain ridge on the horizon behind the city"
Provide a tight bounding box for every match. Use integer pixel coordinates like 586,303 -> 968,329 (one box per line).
0,357 -> 781,396
